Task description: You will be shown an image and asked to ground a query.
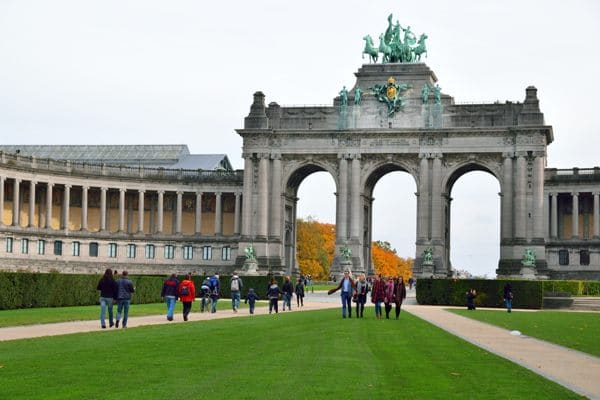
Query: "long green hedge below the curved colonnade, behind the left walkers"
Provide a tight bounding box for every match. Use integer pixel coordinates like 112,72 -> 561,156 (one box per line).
0,272 -> 282,310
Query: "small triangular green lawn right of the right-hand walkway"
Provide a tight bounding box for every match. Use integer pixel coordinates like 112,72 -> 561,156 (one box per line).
449,309 -> 600,357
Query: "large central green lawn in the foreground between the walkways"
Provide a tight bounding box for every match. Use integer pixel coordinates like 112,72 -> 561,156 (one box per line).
0,310 -> 581,400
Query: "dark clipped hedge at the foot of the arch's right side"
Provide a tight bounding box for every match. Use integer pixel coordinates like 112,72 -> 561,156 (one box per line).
417,278 -> 543,309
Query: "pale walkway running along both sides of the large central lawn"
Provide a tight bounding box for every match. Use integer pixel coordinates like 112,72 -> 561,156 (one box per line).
0,291 -> 600,399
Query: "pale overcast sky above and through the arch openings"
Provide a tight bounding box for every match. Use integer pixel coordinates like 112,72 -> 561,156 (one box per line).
0,0 -> 600,276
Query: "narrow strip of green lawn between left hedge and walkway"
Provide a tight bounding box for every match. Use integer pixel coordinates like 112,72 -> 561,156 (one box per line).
0,299 -> 255,328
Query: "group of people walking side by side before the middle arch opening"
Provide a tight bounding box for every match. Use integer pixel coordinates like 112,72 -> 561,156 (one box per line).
327,271 -> 406,319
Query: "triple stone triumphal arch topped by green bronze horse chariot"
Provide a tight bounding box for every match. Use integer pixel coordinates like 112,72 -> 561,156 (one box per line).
237,18 -> 553,277
